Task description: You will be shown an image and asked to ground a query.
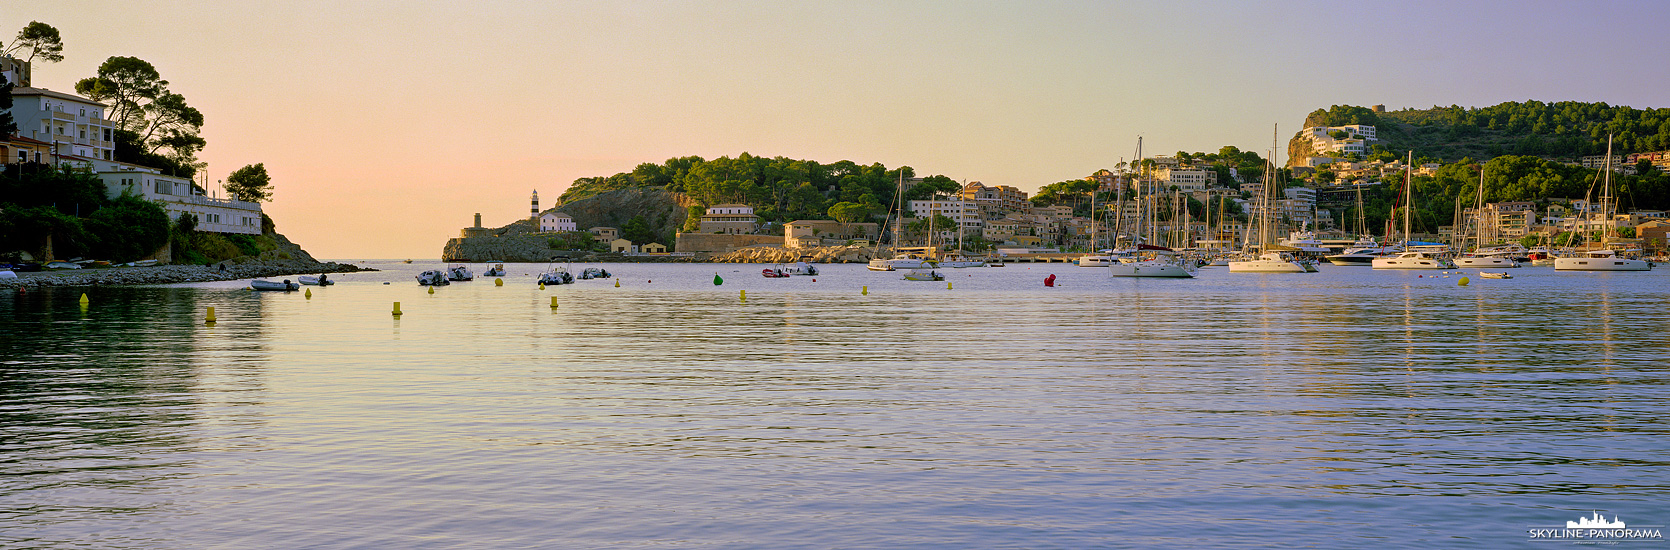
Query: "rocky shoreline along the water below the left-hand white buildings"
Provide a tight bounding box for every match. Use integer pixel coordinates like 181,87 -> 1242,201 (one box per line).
0,261 -> 376,289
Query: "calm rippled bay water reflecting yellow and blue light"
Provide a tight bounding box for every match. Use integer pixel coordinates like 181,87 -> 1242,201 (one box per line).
0,262 -> 1670,548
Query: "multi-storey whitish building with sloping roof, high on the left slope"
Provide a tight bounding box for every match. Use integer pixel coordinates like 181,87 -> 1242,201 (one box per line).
12,87 -> 115,160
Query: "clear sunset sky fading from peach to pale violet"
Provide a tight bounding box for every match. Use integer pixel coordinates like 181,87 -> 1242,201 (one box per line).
13,0 -> 1670,259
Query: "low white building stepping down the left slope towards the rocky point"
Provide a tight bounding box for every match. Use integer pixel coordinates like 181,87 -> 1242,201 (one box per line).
95,162 -> 261,234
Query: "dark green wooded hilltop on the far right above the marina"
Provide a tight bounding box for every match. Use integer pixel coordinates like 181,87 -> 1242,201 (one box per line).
1288,100 -> 1670,166
